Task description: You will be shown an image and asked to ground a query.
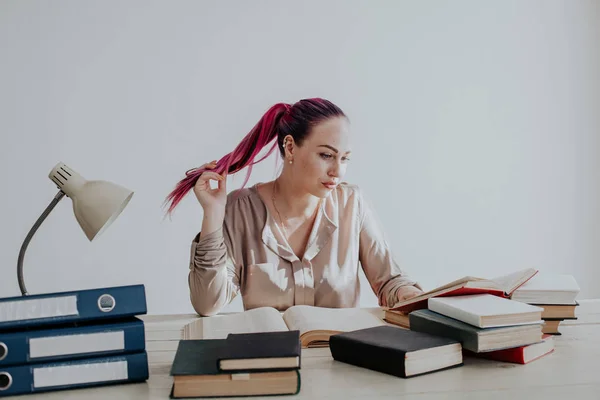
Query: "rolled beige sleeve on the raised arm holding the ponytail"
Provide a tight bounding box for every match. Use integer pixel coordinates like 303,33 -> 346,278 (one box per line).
188,224 -> 240,316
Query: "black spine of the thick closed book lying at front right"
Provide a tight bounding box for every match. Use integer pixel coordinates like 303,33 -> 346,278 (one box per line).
329,335 -> 406,378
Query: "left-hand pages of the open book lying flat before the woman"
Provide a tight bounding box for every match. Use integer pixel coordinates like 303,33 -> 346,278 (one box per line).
183,307 -> 288,340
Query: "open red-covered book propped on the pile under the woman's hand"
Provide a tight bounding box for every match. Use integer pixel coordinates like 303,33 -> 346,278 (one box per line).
389,268 -> 538,314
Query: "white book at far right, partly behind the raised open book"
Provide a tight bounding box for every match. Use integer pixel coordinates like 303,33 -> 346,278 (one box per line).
511,272 -> 580,305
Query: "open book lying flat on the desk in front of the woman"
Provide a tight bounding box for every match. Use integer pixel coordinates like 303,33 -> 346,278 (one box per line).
183,305 -> 387,348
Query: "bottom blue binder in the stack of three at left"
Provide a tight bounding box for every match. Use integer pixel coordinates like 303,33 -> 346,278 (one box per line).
0,351 -> 149,397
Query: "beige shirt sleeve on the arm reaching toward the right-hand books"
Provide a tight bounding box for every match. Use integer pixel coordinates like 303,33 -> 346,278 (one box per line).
357,189 -> 420,307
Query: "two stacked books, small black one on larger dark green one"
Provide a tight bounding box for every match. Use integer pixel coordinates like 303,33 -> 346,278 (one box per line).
170,330 -> 301,398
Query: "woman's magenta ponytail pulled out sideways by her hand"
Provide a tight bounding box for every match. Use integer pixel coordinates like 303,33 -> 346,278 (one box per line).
165,103 -> 290,214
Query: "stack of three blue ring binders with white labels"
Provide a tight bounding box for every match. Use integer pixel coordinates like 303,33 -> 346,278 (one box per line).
0,285 -> 148,397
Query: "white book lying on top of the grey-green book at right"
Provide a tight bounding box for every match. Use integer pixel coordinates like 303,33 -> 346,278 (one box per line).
428,294 -> 544,329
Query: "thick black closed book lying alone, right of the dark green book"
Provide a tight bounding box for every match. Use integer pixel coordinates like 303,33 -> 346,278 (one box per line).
329,326 -> 463,378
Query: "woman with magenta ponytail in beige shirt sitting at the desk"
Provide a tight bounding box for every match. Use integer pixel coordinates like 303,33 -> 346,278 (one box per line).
167,98 -> 422,316
